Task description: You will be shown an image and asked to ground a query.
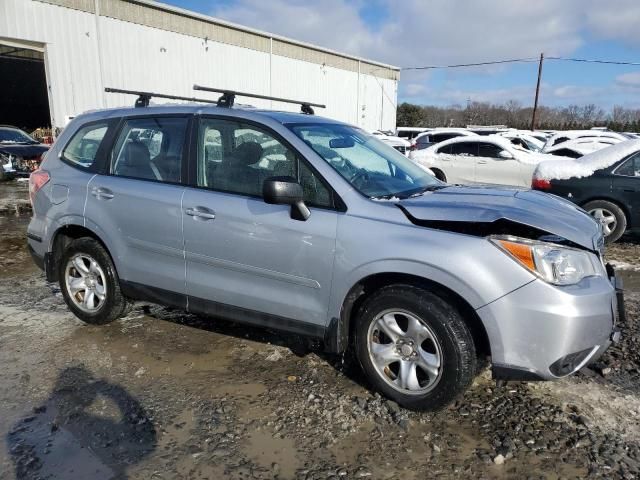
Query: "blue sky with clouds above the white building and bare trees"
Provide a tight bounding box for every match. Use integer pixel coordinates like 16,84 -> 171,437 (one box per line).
163,0 -> 640,110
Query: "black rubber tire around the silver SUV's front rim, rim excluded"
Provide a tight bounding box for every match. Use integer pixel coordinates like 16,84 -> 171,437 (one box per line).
355,284 -> 477,410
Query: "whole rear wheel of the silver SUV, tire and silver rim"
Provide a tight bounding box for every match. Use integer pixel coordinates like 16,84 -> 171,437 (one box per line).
58,237 -> 128,325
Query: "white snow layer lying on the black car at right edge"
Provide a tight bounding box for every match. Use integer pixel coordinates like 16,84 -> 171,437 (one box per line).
534,140 -> 640,180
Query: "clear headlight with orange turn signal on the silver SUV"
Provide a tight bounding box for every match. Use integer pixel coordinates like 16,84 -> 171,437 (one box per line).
489,237 -> 606,285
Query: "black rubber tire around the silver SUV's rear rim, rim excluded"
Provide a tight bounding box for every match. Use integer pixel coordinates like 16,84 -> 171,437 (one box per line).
57,237 -> 129,325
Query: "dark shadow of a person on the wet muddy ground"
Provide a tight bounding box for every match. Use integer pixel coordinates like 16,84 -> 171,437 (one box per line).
7,366 -> 156,480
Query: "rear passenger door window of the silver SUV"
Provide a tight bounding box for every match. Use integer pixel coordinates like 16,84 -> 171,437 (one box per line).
110,117 -> 188,183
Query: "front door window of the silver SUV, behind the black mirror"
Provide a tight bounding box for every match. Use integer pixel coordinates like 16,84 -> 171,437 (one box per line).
197,119 -> 333,207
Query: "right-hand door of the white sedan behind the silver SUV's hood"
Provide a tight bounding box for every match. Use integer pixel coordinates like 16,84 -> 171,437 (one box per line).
476,142 -> 533,187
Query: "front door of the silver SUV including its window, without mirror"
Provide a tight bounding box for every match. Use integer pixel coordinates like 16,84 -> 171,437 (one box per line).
183,118 -> 338,327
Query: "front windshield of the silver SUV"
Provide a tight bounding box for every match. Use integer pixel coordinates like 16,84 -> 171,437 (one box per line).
287,123 -> 444,198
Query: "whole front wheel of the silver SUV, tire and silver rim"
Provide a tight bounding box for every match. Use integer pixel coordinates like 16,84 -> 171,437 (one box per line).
356,285 -> 477,410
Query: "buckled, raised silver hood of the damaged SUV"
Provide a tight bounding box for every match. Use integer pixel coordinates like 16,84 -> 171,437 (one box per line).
398,185 -> 601,250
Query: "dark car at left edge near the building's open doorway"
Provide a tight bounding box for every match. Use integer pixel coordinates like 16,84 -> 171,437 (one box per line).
0,125 -> 49,176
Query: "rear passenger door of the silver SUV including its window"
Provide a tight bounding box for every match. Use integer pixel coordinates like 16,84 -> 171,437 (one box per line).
86,116 -> 189,299
